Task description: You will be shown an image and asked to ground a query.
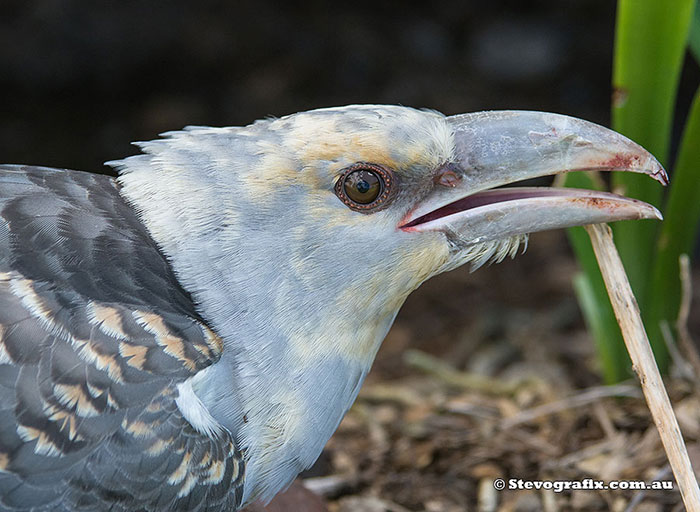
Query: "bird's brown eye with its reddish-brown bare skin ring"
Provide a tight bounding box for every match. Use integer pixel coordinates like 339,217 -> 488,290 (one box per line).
335,162 -> 396,213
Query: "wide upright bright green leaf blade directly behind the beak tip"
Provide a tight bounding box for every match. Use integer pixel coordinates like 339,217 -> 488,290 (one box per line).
612,0 -> 695,369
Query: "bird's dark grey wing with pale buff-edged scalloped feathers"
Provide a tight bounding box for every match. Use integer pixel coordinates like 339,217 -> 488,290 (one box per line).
0,167 -> 243,511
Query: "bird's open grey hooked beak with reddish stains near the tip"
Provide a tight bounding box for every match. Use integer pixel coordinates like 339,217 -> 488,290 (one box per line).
400,111 -> 668,245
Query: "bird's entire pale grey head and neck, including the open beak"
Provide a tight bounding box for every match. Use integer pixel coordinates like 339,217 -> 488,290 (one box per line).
112,106 -> 666,495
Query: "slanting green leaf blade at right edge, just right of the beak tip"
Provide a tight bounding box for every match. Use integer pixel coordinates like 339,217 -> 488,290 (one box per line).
646,88 -> 700,358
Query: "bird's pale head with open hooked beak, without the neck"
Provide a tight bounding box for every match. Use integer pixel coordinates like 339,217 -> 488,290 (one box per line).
121,105 -> 666,324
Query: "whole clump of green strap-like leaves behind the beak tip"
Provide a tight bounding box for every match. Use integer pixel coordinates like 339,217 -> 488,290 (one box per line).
568,0 -> 700,382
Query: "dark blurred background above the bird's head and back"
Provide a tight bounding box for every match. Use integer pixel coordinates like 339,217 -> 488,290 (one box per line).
0,0 -> 699,175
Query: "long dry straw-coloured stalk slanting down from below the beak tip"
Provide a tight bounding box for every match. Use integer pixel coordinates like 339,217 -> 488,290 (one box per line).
586,224 -> 700,512
